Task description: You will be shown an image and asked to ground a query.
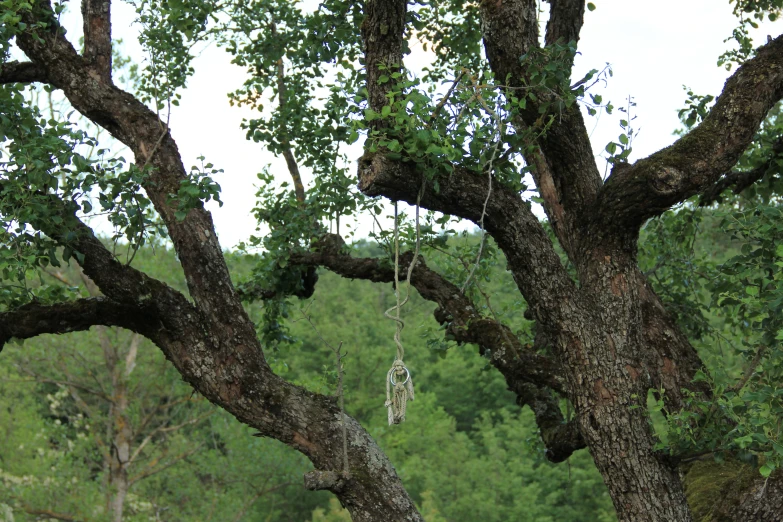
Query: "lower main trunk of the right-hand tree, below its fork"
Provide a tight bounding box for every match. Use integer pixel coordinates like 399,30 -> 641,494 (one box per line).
558,276 -> 691,522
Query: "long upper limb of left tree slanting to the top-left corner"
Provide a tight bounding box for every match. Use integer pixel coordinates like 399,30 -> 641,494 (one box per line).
17,0 -> 251,338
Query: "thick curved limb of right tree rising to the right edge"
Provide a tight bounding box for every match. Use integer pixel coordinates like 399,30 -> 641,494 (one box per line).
590,35 -> 783,235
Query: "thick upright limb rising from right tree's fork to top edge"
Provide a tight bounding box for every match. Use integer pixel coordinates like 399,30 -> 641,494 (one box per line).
481,0 -> 601,263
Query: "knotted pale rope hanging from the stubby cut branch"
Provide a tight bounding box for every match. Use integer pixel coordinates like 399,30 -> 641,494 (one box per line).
383,183 -> 425,426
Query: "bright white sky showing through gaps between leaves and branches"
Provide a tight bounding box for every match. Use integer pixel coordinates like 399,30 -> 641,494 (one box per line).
67,0 -> 783,248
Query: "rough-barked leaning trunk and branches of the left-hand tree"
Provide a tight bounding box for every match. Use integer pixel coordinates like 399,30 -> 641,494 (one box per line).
0,0 -> 421,521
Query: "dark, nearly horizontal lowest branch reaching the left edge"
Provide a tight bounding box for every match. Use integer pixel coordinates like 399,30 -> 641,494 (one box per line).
0,297 -> 158,351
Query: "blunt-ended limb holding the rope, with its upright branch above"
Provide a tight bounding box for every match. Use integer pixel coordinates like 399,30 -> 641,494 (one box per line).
359,0 -> 574,332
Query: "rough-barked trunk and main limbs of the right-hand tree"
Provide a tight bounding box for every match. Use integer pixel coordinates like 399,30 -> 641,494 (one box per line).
359,0 -> 783,521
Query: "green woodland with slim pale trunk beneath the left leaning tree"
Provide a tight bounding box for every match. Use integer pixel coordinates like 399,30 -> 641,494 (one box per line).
0,245 -> 320,521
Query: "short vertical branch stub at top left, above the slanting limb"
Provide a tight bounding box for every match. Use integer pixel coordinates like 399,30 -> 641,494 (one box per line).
82,0 -> 112,83
